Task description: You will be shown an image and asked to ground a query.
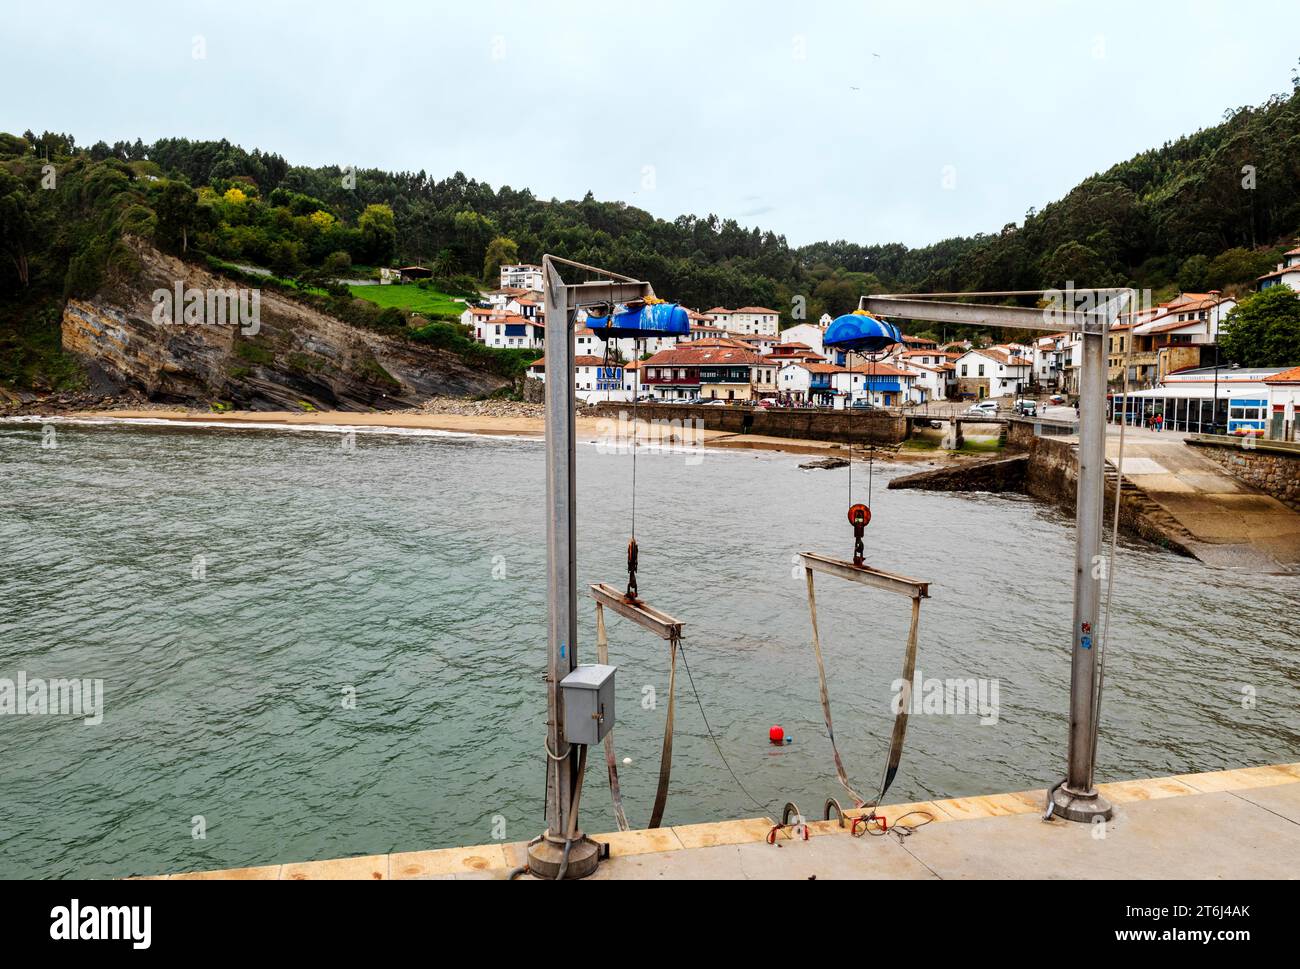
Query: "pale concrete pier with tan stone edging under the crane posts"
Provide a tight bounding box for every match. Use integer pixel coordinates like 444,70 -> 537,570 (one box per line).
144,763 -> 1300,881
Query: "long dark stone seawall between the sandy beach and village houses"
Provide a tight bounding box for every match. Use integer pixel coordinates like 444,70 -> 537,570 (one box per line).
586,401 -> 907,445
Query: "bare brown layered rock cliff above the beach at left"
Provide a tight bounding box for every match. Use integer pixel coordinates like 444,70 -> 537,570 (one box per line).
62,241 -> 508,411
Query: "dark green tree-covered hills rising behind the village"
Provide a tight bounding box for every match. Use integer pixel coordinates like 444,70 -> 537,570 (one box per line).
0,82 -> 1300,387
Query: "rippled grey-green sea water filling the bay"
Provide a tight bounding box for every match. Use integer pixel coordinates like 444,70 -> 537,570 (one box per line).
0,424 -> 1300,877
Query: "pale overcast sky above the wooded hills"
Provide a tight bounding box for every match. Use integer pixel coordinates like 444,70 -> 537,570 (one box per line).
0,0 -> 1300,245
